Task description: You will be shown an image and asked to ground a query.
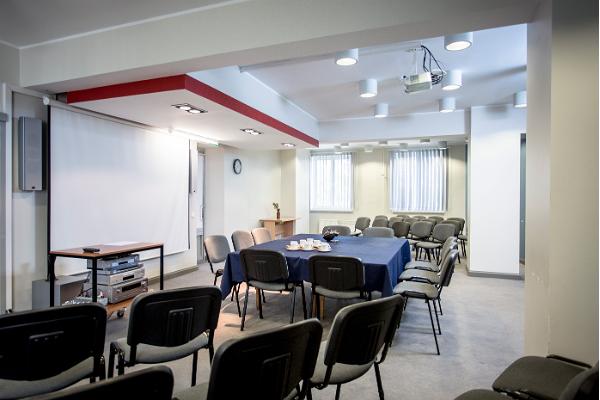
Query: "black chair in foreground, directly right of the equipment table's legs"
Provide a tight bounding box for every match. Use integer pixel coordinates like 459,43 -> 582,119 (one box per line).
108,286 -> 221,386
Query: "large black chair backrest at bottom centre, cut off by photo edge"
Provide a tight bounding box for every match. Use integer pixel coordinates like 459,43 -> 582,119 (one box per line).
206,318 -> 323,400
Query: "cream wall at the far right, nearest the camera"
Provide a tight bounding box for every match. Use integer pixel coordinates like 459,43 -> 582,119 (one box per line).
525,0 -> 598,363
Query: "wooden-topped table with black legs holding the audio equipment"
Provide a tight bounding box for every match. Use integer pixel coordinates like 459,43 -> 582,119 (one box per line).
48,243 -> 164,307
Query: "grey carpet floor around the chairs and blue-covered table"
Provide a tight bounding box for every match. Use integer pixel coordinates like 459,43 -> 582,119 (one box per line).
106,255 -> 523,400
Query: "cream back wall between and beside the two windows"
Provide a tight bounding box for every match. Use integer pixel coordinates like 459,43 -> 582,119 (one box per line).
310,145 -> 466,232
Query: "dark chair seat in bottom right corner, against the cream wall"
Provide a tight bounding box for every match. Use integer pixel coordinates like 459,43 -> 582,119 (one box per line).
492,355 -> 598,400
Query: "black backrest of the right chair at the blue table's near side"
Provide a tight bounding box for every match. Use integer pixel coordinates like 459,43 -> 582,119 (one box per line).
308,255 -> 365,291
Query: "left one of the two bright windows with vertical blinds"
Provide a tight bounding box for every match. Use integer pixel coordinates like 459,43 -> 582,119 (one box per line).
310,153 -> 353,211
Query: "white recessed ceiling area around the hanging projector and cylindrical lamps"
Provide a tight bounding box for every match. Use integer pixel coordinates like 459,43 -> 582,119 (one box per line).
241,25 -> 527,121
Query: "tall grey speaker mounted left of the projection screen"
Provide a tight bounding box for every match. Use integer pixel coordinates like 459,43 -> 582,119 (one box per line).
19,117 -> 44,191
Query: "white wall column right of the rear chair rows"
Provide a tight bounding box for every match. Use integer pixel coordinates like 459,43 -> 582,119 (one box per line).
469,105 -> 526,274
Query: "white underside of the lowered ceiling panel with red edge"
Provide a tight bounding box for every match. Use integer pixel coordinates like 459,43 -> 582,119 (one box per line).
72,89 -> 312,150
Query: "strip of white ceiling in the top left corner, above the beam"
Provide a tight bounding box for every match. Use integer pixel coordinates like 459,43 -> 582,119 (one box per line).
0,0 -> 234,47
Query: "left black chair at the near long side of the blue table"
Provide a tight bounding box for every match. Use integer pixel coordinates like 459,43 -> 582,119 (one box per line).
240,249 -> 307,331
